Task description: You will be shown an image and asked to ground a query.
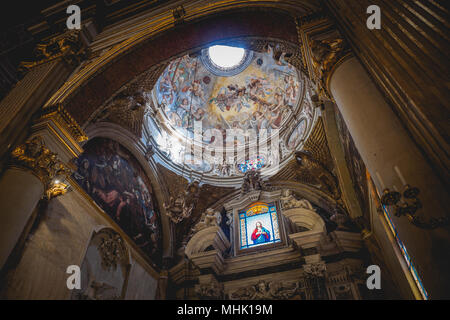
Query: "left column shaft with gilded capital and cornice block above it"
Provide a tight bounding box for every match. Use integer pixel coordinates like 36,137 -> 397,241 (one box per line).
0,102 -> 87,269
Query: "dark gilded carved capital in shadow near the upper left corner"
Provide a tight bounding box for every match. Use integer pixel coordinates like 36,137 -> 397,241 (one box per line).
19,30 -> 87,73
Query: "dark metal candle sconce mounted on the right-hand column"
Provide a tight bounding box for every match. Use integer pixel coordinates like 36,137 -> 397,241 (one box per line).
381,184 -> 450,229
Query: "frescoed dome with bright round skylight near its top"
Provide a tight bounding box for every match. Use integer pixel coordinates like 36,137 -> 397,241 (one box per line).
142,45 -> 315,184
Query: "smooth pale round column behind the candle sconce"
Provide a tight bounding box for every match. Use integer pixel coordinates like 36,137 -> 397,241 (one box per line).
327,55 -> 450,298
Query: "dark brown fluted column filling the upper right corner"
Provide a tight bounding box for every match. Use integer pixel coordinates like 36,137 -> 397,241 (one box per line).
324,0 -> 450,184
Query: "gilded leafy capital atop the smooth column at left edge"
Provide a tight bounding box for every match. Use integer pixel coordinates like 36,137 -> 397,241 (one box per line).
10,136 -> 72,189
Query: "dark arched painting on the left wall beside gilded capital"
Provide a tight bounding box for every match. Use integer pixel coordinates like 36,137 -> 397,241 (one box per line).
73,138 -> 162,264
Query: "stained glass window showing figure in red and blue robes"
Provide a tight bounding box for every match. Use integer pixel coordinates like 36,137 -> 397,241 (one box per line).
239,202 -> 281,249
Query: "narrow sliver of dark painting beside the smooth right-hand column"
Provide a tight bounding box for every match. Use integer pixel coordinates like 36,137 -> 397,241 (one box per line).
335,107 -> 370,221
